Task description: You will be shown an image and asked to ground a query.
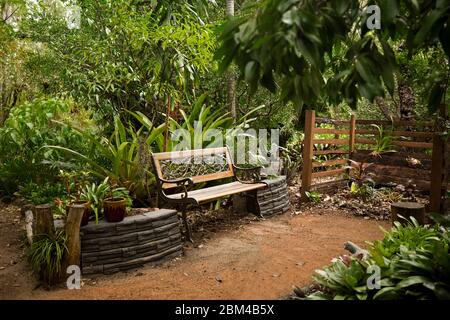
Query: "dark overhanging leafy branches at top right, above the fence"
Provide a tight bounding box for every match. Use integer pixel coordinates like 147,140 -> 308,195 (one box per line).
218,0 -> 450,110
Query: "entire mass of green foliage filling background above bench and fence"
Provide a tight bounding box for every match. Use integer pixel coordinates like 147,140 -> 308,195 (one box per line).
0,0 -> 450,212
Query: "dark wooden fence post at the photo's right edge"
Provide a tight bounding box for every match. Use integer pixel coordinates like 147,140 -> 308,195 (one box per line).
430,105 -> 447,212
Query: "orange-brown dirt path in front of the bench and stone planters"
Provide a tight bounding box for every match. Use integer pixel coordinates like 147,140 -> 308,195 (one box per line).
0,202 -> 388,299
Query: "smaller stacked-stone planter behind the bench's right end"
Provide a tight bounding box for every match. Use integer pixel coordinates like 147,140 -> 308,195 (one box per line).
256,176 -> 291,217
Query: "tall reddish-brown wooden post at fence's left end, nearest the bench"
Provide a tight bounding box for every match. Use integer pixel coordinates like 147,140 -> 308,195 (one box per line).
301,110 -> 316,202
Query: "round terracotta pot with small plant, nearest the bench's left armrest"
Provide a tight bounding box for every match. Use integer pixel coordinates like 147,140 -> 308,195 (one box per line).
103,187 -> 131,222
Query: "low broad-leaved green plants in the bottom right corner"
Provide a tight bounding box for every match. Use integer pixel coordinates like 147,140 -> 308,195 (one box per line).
308,218 -> 450,300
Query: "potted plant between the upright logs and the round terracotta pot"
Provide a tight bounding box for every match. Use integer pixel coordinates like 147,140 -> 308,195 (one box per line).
59,170 -> 92,226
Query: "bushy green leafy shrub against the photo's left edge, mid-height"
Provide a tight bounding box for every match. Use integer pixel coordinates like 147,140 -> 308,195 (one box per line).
0,99 -> 94,195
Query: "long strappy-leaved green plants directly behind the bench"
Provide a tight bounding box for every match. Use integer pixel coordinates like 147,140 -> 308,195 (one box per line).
46,95 -> 257,204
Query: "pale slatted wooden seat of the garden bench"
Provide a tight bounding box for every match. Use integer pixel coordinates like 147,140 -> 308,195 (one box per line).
167,181 -> 266,204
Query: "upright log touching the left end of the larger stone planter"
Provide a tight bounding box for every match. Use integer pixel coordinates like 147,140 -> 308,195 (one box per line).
63,204 -> 85,270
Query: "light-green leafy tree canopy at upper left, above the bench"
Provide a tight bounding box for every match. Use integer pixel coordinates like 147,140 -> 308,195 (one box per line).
18,0 -> 215,116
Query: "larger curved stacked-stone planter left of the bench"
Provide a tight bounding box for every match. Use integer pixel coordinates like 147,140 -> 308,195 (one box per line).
81,209 -> 182,274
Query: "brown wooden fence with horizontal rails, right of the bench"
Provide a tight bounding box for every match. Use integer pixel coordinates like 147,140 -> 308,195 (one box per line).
301,106 -> 450,212
